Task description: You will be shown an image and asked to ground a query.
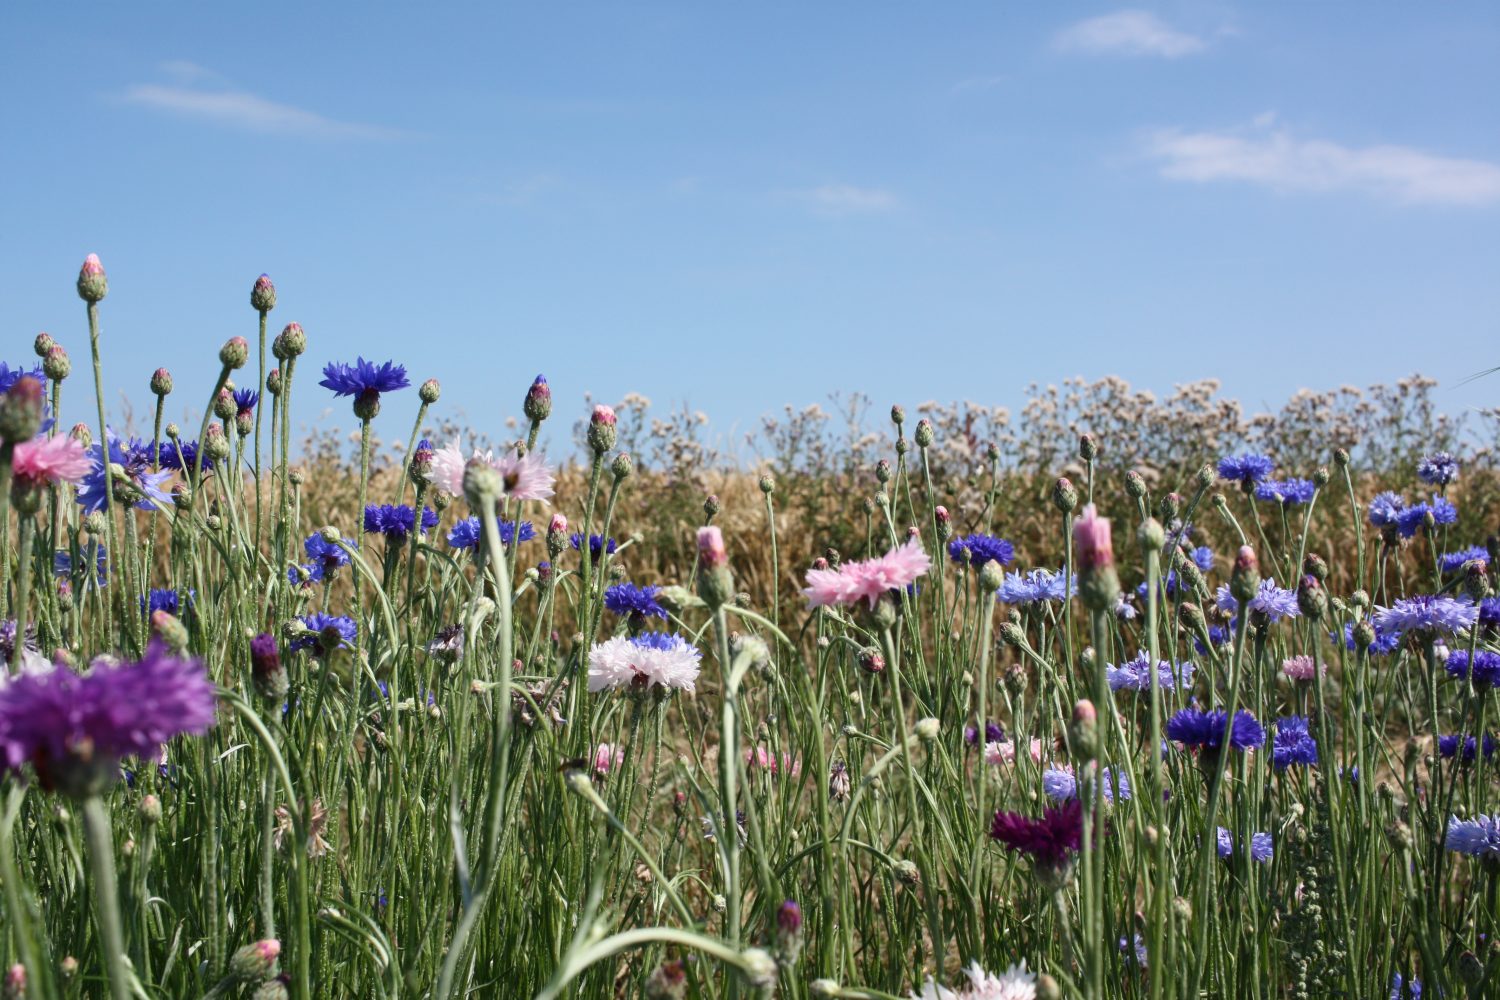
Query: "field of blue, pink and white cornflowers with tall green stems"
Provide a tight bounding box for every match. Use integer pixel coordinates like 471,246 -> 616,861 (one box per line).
0,256 -> 1500,1000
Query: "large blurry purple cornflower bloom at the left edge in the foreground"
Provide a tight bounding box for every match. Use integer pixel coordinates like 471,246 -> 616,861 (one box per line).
0,640 -> 216,798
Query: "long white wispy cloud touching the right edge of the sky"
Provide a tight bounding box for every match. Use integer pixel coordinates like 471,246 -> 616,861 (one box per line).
1145,114 -> 1500,205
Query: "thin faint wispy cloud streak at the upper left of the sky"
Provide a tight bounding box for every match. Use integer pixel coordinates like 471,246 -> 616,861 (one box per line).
120,60 -> 407,139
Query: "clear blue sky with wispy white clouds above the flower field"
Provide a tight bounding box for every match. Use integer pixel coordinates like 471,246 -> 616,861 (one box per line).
0,1 -> 1500,449
